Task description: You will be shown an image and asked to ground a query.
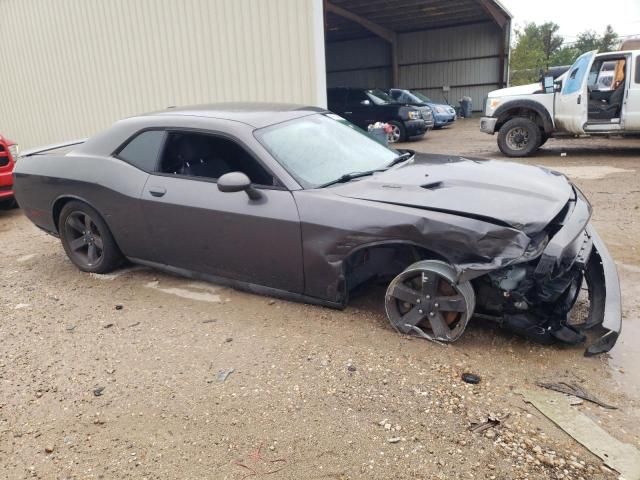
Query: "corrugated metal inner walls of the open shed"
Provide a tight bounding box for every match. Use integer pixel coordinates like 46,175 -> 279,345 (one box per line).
326,22 -> 504,110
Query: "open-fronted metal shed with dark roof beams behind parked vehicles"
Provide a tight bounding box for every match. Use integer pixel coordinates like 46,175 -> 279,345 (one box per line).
325,0 -> 511,110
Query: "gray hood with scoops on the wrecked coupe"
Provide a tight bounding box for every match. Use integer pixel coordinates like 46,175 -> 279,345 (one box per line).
334,154 -> 575,234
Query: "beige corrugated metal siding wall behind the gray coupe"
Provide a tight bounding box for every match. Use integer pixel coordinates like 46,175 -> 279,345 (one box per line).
0,0 -> 326,147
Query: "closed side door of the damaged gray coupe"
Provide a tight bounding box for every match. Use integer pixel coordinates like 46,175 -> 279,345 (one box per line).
142,132 -> 304,293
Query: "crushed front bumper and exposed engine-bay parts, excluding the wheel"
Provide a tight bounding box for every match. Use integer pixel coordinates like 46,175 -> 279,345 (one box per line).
470,189 -> 622,355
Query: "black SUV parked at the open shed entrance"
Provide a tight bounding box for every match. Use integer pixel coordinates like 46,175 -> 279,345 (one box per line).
327,87 -> 433,143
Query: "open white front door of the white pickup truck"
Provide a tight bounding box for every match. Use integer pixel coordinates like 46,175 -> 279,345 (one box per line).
555,50 -> 597,134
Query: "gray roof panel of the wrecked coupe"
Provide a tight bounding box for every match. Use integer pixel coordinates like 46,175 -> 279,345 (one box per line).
141,102 -> 327,128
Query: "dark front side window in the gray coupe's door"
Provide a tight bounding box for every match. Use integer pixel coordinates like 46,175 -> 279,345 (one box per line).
159,132 -> 278,186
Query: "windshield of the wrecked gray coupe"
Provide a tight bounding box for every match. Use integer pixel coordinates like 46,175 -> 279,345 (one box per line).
256,115 -> 399,188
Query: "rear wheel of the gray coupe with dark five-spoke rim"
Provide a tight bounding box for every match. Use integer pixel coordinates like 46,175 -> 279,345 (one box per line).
58,201 -> 123,273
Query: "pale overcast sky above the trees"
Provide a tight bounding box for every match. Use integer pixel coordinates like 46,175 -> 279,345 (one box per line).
499,0 -> 640,42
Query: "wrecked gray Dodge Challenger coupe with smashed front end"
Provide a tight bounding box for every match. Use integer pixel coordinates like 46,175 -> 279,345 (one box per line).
15,104 -> 621,355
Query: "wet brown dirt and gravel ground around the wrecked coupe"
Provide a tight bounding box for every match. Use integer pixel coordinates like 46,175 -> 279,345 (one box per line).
0,120 -> 640,480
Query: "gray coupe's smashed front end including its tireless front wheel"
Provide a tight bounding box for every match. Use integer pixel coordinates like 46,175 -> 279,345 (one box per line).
386,187 -> 622,356
